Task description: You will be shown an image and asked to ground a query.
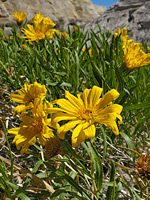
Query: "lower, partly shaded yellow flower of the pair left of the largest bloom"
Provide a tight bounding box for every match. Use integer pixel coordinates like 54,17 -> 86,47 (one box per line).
8,99 -> 54,156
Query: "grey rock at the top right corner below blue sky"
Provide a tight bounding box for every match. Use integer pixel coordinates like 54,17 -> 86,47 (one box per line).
85,0 -> 150,43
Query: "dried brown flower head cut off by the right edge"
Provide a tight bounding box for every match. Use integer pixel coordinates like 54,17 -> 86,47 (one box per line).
136,154 -> 150,180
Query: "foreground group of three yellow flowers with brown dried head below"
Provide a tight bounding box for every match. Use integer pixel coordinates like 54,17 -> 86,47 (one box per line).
8,82 -> 123,155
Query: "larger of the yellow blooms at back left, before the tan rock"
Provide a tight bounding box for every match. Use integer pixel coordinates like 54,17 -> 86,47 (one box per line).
22,12 -> 56,42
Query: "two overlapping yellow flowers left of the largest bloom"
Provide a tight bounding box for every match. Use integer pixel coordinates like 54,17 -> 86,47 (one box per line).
8,82 -> 54,155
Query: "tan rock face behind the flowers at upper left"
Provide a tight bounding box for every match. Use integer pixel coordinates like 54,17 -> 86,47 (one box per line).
0,0 -> 106,29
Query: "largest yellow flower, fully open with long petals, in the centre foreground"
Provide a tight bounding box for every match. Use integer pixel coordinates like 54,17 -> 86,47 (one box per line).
47,86 -> 123,147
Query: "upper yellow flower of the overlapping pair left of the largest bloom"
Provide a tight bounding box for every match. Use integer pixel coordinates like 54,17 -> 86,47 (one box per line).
9,82 -> 47,114
